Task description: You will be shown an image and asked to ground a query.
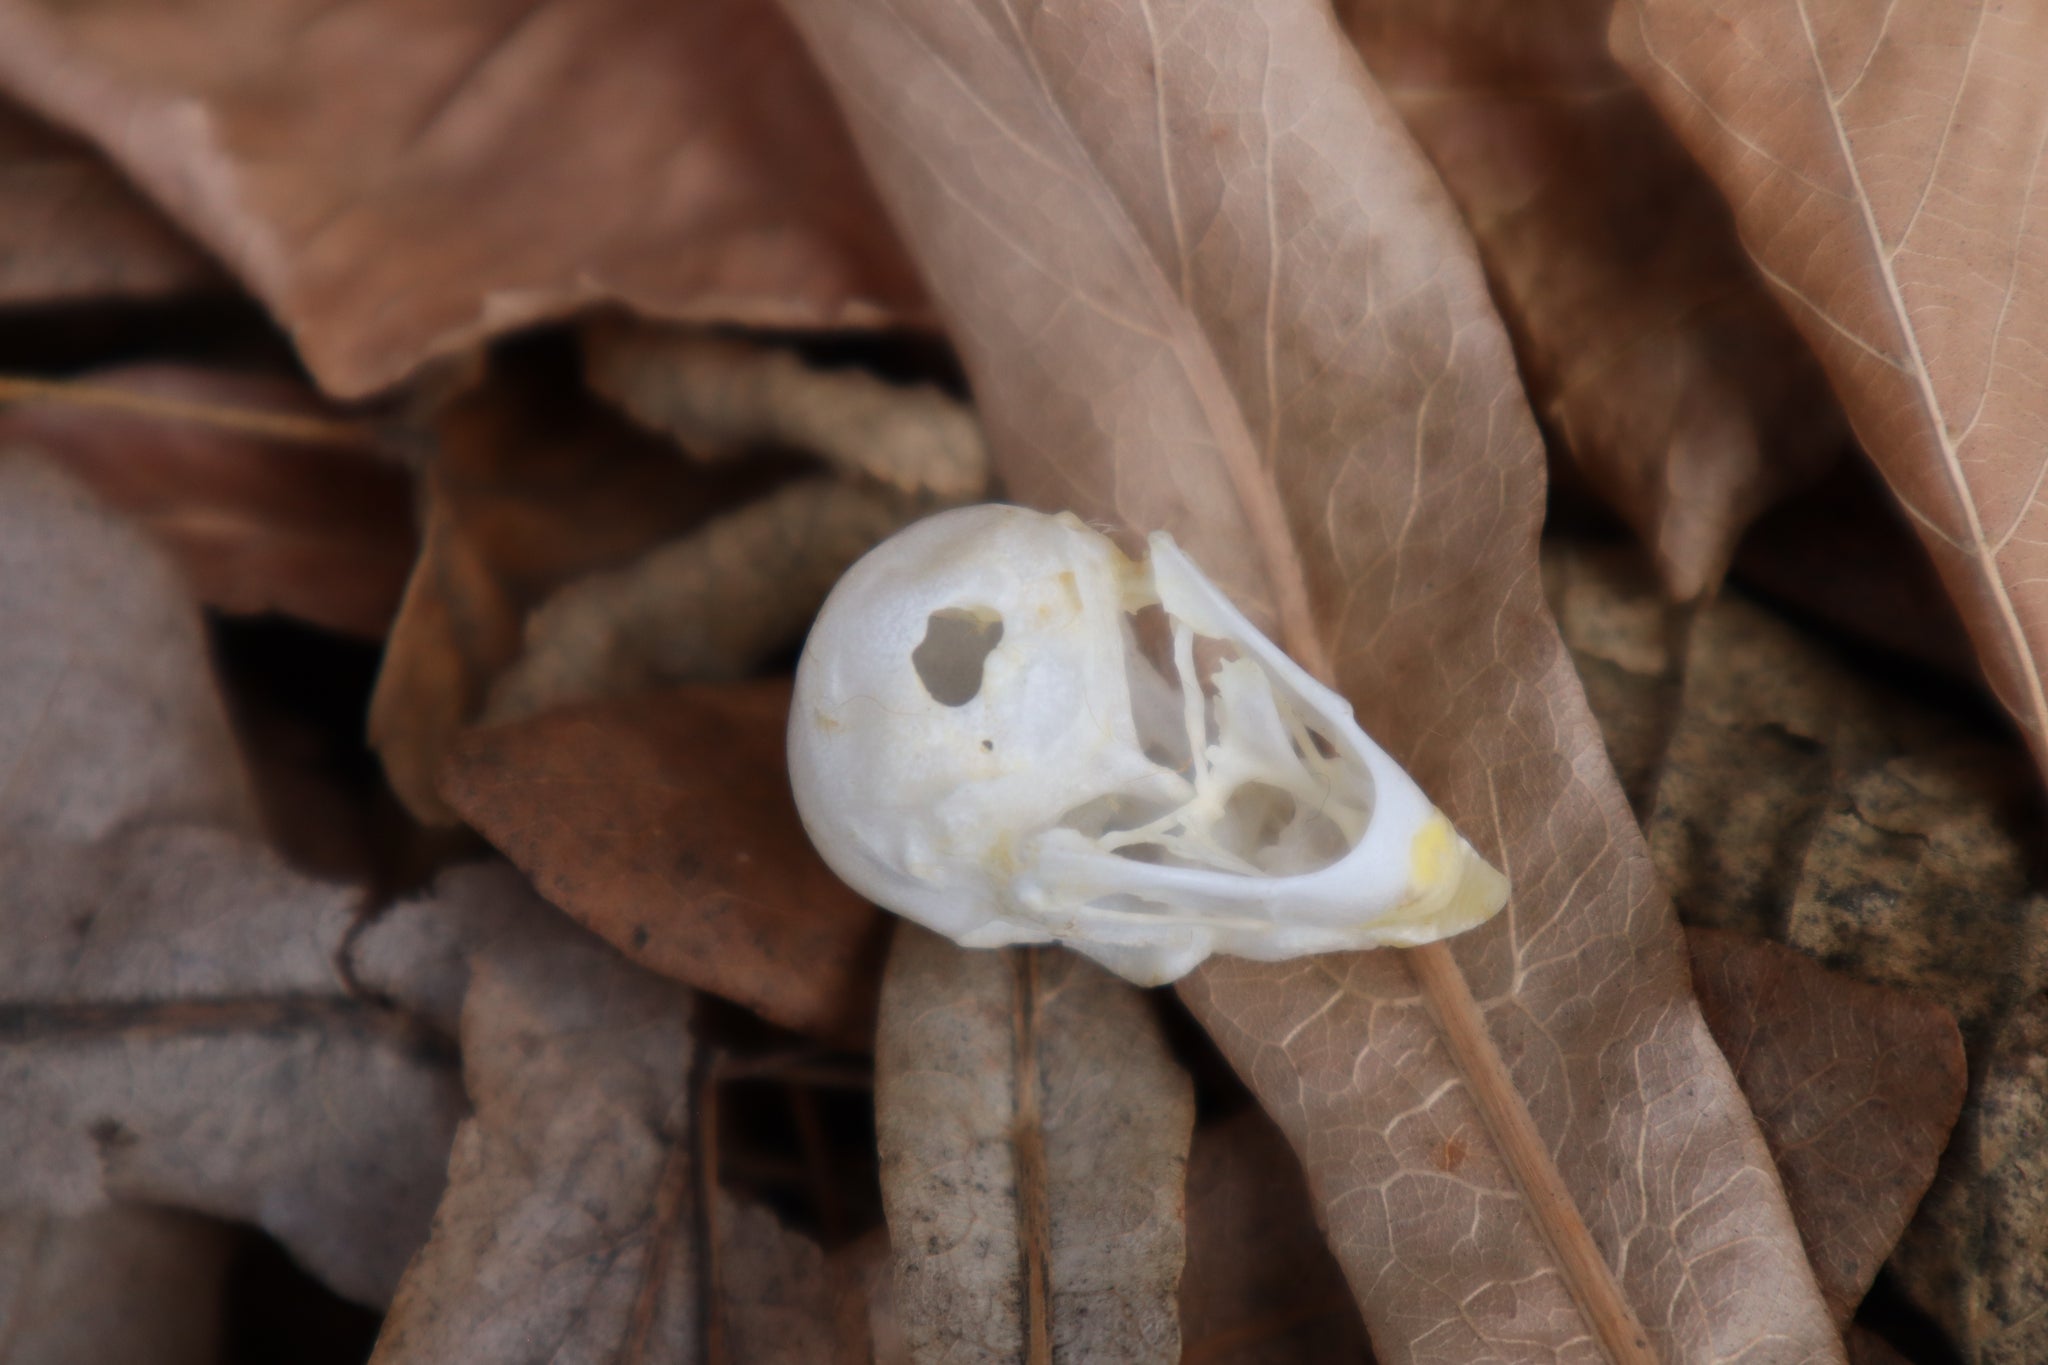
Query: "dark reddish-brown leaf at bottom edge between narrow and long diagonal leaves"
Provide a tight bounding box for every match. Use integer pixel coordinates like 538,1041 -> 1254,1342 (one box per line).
1180,1111 -> 1372,1365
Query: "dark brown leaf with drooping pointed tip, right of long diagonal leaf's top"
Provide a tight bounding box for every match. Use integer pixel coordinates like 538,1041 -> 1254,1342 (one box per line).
1339,0 -> 1847,600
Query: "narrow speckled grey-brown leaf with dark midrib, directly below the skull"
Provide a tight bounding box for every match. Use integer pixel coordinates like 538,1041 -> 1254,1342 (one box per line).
874,923 -> 1194,1365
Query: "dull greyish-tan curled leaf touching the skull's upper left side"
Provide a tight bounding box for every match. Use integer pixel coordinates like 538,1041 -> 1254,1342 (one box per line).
483,479 -> 915,722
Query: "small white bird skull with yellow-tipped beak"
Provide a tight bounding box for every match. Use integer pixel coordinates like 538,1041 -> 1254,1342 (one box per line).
788,505 -> 1507,984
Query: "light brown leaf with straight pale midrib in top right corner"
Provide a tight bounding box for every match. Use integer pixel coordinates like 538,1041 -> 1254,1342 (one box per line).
1612,0 -> 2048,785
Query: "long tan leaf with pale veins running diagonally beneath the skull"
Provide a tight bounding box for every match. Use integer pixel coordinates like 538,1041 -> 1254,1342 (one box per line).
791,0 -> 1841,1363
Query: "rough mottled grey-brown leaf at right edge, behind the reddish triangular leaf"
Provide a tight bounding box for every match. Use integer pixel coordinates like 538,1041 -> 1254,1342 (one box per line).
1561,540 -> 2048,1361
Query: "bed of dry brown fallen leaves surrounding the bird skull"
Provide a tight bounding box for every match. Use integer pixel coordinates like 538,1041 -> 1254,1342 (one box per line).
0,0 -> 2048,1363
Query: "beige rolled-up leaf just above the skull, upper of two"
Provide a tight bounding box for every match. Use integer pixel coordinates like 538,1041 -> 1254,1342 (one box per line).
584,319 -> 989,501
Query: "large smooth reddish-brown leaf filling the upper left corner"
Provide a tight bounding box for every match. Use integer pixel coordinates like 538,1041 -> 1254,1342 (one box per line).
0,0 -> 920,397
